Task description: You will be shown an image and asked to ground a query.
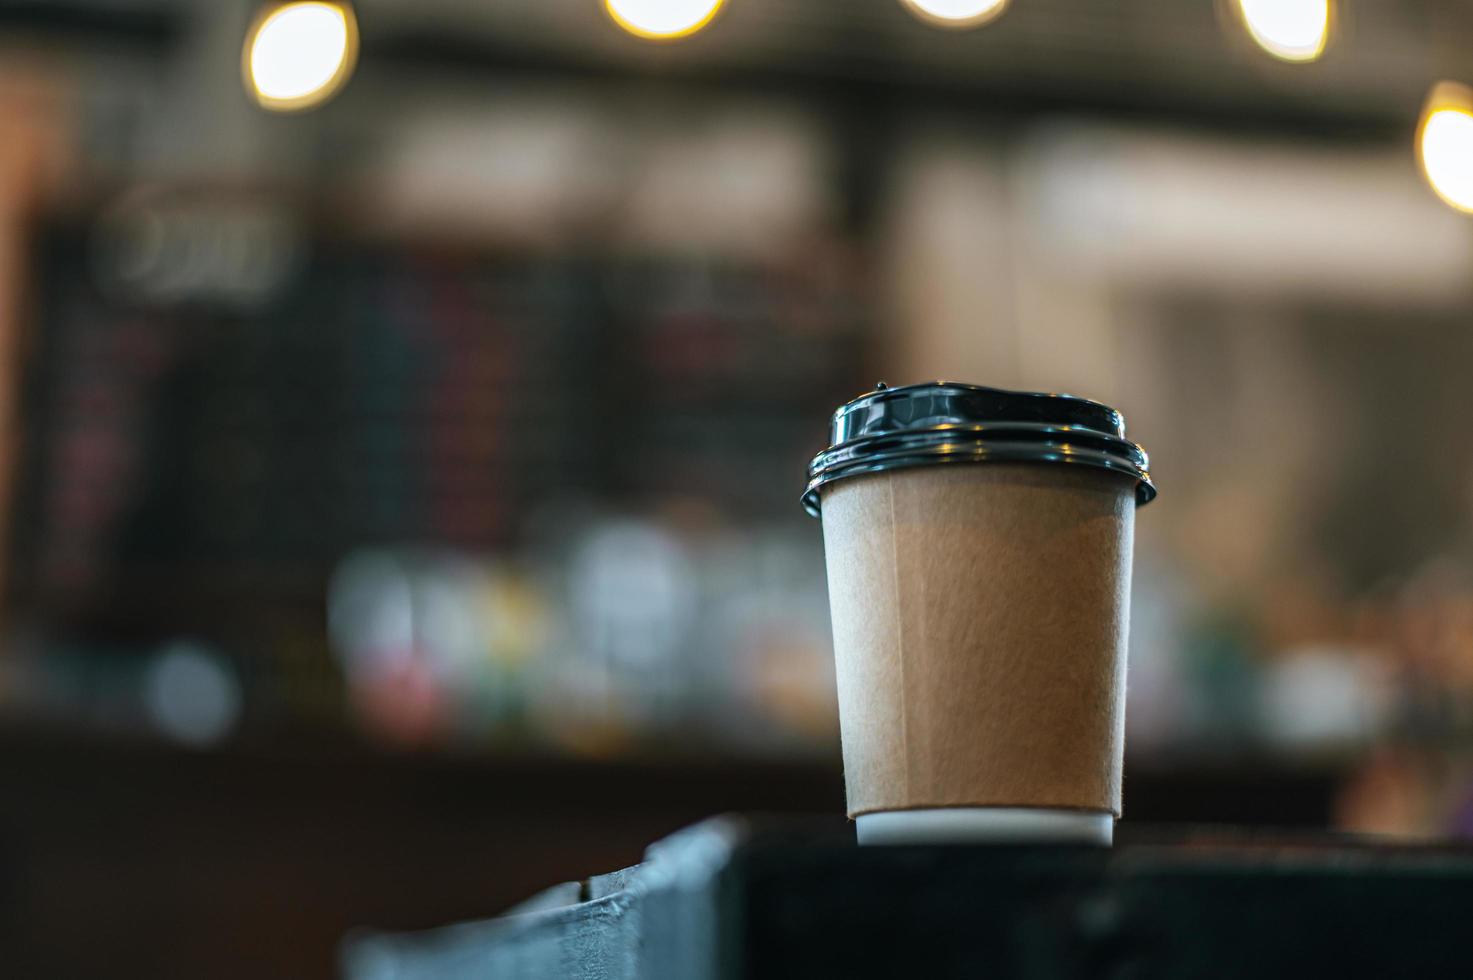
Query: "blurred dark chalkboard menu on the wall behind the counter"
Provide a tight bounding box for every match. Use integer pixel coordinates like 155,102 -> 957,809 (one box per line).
9,216 -> 872,629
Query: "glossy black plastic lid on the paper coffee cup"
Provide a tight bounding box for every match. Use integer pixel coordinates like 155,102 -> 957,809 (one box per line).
803,382 -> 1156,517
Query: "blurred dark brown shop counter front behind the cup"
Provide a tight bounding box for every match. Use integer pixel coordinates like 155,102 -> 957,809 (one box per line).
0,727 -> 1342,980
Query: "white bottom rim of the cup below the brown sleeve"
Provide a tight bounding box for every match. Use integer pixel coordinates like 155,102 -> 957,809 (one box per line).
854,806 -> 1115,847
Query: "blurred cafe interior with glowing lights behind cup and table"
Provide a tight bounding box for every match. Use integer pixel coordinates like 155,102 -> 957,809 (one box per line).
0,0 -> 1473,977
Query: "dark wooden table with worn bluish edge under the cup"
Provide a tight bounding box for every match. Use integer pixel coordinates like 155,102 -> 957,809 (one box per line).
345,818 -> 1473,980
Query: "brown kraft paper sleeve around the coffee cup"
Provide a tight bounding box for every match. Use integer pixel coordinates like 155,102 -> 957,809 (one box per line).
820,463 -> 1137,816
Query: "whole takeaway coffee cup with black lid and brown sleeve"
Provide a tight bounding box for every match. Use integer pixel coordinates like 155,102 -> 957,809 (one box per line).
804,383 -> 1155,843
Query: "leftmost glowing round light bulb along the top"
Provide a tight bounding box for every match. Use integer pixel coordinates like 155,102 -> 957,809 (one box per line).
243,1 -> 358,111
